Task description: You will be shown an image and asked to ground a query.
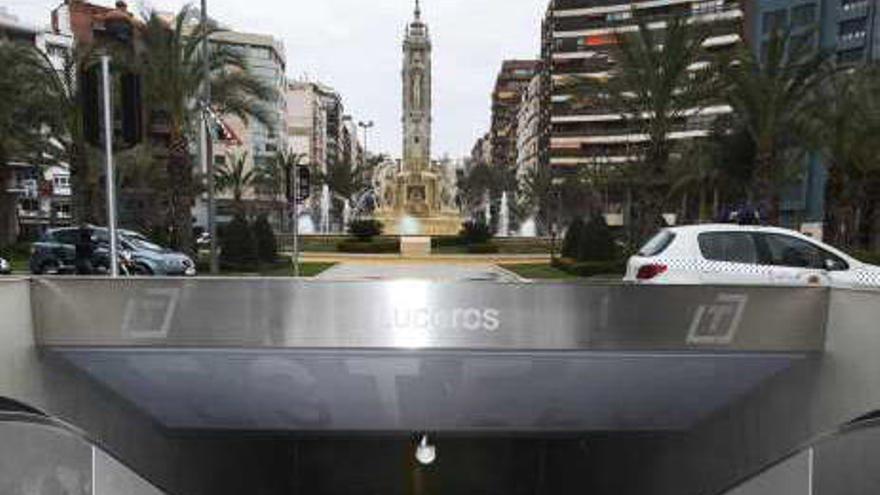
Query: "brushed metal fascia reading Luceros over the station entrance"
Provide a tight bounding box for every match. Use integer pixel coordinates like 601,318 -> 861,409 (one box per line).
32,278 -> 829,352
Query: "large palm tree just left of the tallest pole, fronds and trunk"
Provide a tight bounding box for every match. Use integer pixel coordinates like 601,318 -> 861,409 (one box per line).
144,6 -> 277,251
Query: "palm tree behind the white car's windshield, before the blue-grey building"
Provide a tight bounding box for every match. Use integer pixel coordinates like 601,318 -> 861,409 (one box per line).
724,31 -> 829,223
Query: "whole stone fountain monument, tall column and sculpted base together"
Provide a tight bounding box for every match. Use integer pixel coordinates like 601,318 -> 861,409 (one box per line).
374,0 -> 462,235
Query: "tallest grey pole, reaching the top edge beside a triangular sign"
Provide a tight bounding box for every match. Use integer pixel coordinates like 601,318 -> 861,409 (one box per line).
199,0 -> 220,275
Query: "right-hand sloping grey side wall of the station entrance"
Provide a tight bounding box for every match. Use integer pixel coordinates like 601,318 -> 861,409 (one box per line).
626,290 -> 880,495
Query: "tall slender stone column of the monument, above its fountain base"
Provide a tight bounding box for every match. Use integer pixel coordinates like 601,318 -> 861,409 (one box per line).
402,0 -> 431,172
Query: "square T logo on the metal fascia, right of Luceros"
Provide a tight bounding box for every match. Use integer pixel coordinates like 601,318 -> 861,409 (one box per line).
687,294 -> 749,345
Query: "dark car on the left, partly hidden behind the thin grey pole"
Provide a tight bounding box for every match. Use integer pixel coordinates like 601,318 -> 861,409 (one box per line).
30,227 -> 196,276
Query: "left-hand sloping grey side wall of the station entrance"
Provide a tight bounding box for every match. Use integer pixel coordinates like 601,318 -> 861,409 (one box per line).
0,279 -> 296,495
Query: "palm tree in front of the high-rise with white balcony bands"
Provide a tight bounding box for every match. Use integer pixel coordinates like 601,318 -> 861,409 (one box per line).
577,17 -> 719,243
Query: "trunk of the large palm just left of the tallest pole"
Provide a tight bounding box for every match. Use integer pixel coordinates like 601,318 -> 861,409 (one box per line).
167,136 -> 195,255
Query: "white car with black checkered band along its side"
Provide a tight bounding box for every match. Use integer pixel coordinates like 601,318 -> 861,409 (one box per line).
624,224 -> 880,288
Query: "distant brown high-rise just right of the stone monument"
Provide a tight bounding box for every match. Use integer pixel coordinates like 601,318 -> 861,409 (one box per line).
490,60 -> 540,172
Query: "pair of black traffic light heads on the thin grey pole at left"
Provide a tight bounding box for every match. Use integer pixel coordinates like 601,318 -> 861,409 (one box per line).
80,64 -> 144,150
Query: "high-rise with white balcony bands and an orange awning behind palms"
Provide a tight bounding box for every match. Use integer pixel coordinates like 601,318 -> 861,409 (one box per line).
539,0 -> 743,219
